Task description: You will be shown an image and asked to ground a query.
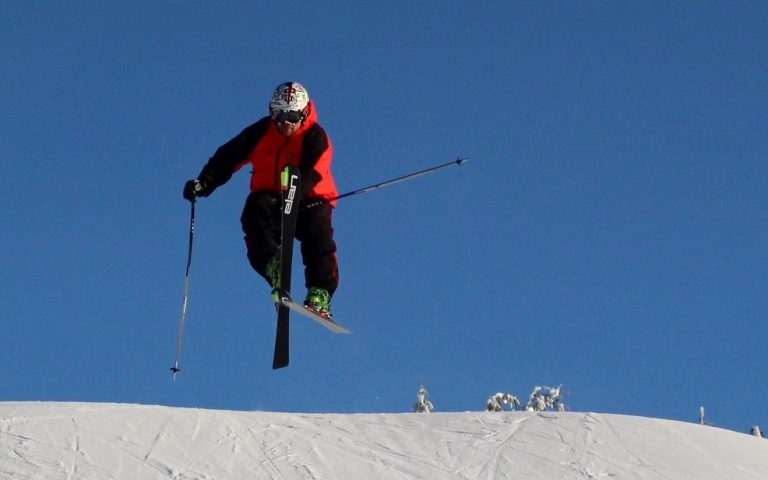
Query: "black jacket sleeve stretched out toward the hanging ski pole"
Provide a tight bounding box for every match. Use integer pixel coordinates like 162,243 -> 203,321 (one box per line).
197,117 -> 270,194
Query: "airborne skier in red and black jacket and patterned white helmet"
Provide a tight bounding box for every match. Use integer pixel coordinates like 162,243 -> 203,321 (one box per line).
183,82 -> 339,319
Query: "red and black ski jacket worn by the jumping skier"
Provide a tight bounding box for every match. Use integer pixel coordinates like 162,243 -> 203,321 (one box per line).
198,101 -> 338,205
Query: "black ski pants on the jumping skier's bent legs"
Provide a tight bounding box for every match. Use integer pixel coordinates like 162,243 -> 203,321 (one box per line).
240,191 -> 339,294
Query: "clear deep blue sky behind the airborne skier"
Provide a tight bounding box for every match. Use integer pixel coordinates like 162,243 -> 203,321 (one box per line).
0,1 -> 768,430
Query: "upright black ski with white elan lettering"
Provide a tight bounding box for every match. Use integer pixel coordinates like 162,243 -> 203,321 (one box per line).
272,165 -> 301,369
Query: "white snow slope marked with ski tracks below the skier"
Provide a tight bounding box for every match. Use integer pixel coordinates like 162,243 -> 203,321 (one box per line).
0,403 -> 768,480
